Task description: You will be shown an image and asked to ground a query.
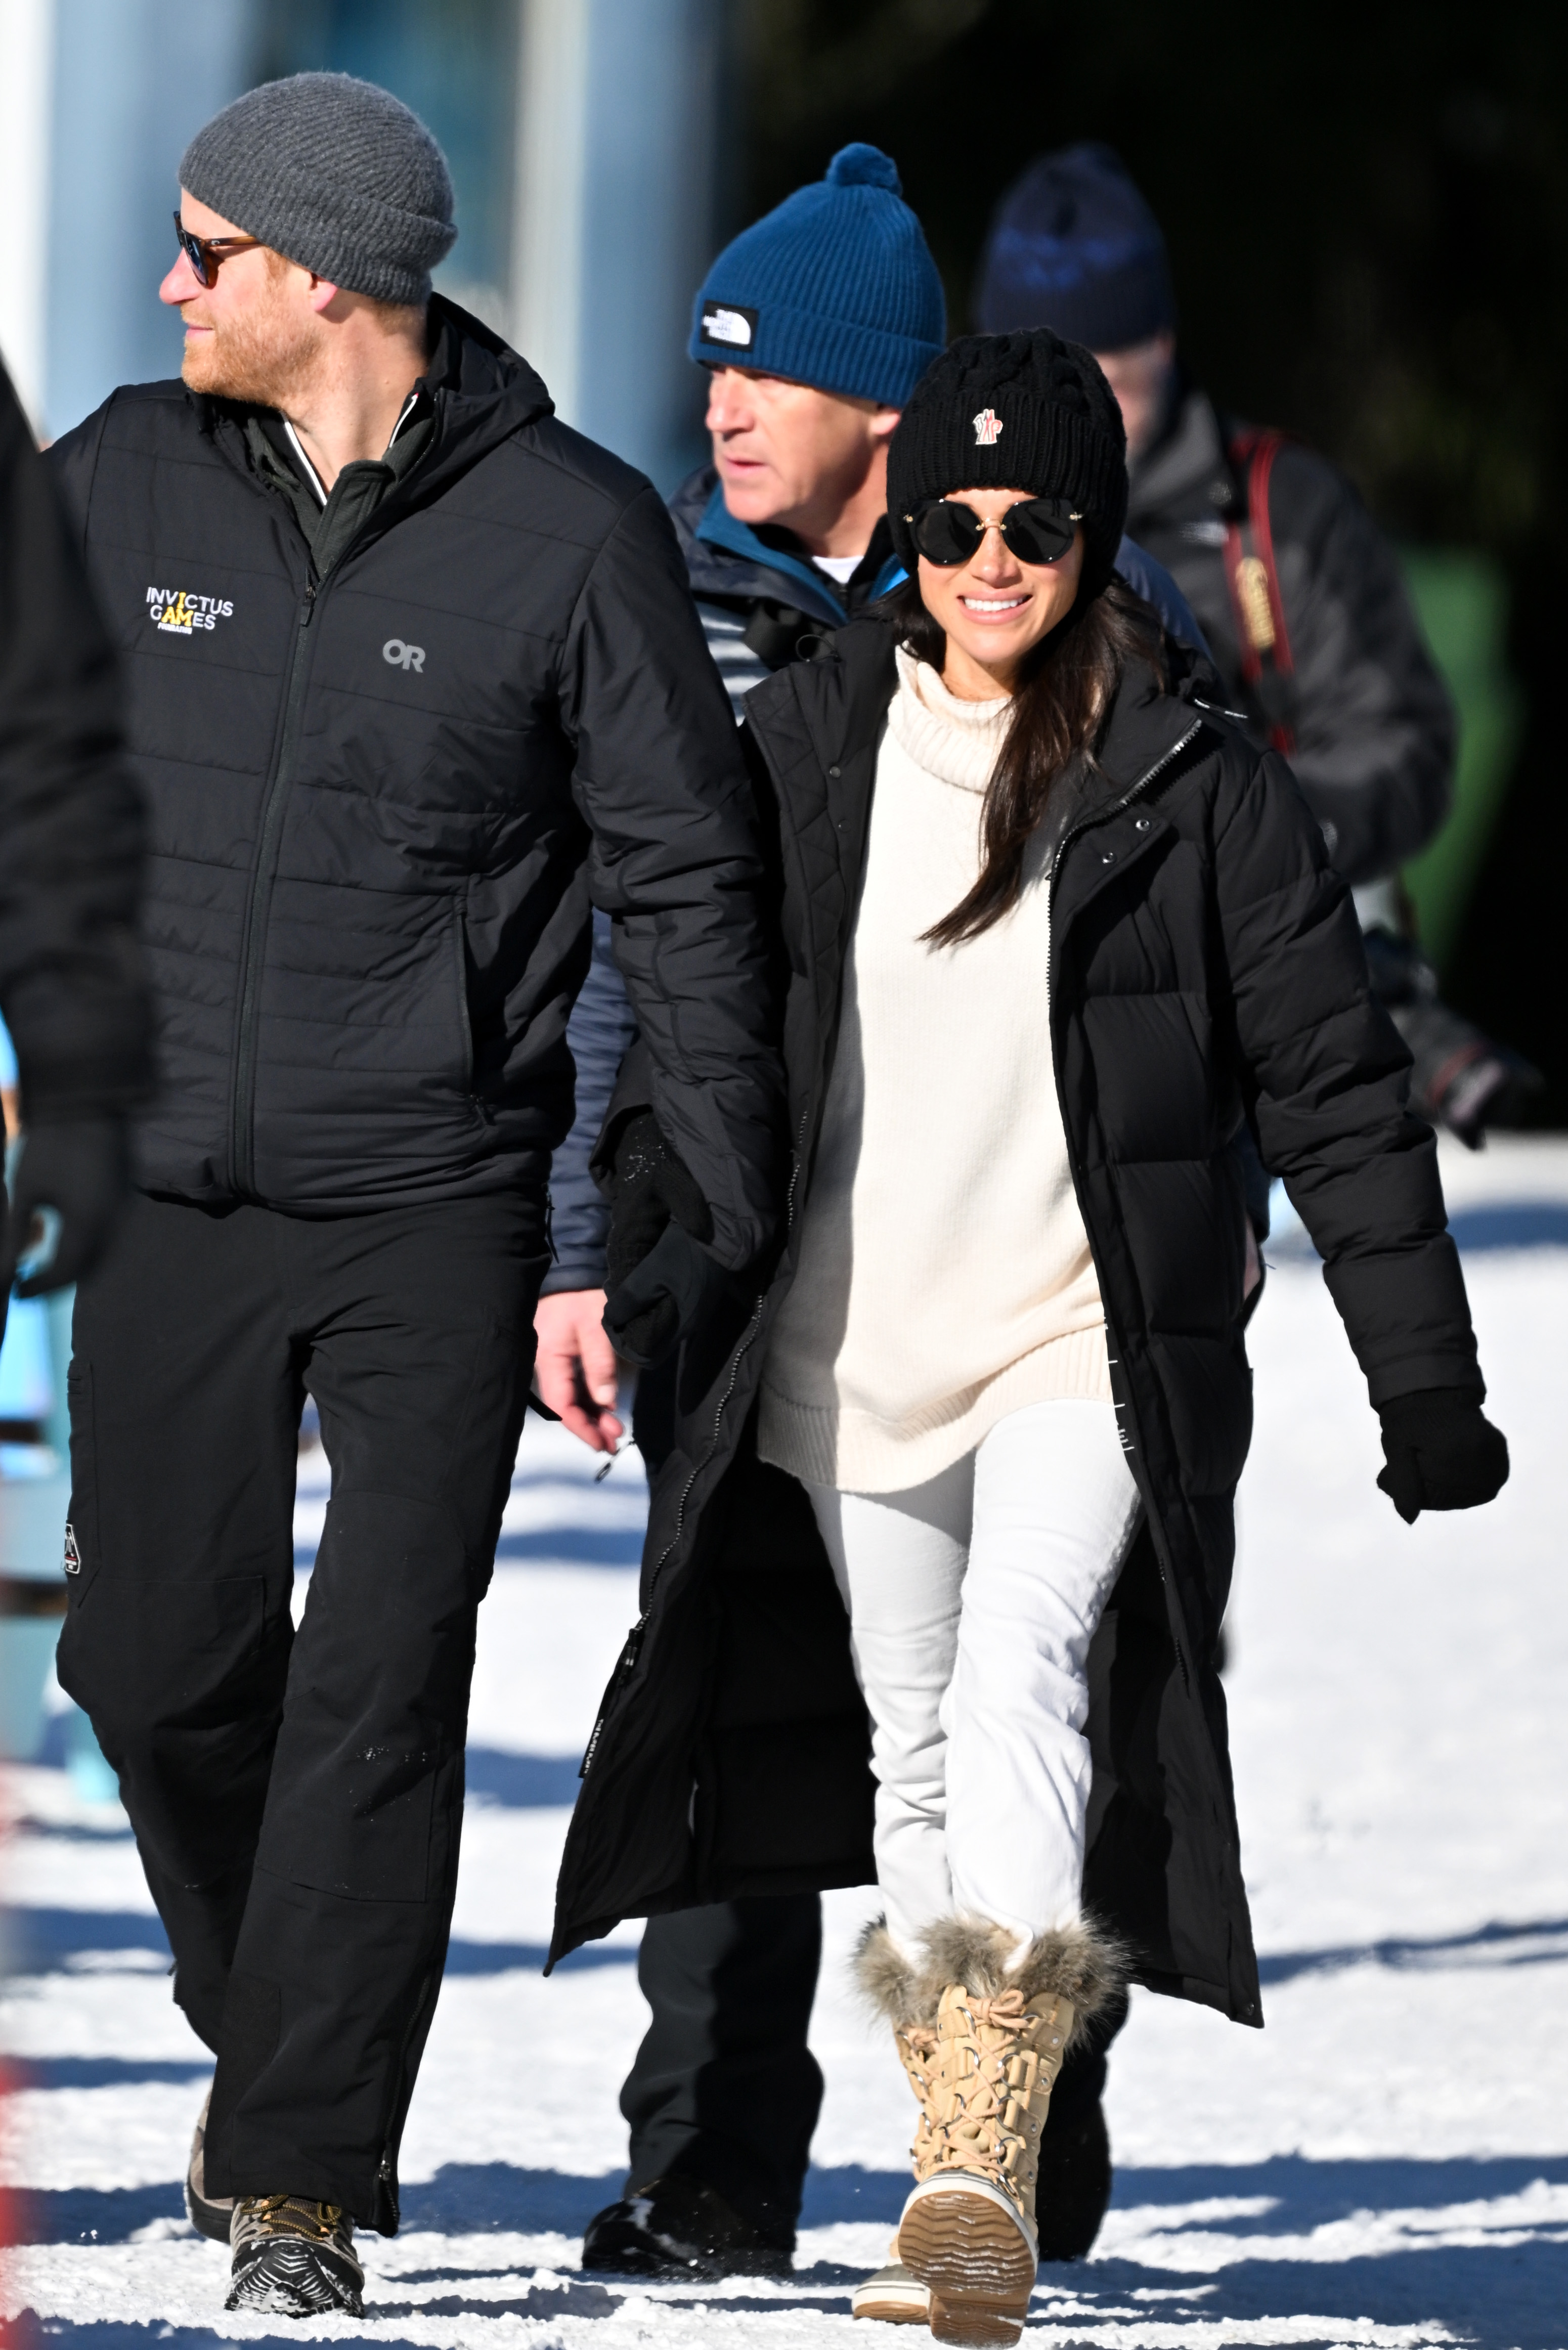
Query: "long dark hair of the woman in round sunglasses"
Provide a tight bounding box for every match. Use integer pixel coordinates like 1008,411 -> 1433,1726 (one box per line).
891,578 -> 1168,947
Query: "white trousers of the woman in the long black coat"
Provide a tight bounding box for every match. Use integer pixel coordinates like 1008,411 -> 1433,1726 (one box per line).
806,1401 -> 1140,1957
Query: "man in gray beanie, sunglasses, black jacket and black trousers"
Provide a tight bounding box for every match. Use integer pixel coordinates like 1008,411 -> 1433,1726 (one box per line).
52,73 -> 783,2317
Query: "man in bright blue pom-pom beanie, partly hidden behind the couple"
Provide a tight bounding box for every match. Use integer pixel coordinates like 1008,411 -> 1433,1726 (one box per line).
536,146 -> 1197,2284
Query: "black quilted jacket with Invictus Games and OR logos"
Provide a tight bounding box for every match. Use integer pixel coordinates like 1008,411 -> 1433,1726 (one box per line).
46,301 -> 778,1269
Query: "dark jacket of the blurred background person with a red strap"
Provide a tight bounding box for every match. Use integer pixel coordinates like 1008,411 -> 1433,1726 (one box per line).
1126,390 -> 1455,884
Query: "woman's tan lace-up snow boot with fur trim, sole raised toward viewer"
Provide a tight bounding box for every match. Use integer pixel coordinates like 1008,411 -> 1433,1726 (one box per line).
858,1918 -> 1126,2350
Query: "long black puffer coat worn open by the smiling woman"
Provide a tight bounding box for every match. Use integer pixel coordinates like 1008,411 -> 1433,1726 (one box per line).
555,618 -> 1481,2023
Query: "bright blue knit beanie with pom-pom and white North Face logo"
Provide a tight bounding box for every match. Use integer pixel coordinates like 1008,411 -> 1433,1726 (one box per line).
689,143 -> 947,409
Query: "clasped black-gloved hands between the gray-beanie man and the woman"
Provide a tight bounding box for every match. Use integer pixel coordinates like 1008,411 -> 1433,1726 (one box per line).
604,1109 -> 724,1370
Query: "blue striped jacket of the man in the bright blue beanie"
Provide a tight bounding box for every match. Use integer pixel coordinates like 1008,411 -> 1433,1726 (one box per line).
545,465 -> 1222,1295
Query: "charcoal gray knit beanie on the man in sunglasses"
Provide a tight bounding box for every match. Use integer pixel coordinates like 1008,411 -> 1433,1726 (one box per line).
179,73 -> 456,303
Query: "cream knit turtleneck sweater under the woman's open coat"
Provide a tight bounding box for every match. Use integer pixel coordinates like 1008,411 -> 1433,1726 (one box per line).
759,651 -> 1112,1492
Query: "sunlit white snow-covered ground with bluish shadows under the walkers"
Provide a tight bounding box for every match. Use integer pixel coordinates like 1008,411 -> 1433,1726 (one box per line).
5,1142 -> 1568,2350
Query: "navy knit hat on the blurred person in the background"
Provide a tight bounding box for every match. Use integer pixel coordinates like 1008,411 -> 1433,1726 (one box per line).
976,143 -> 1175,350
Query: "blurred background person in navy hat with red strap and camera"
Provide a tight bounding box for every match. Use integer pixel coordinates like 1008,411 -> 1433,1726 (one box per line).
976,143 -> 1531,1145
